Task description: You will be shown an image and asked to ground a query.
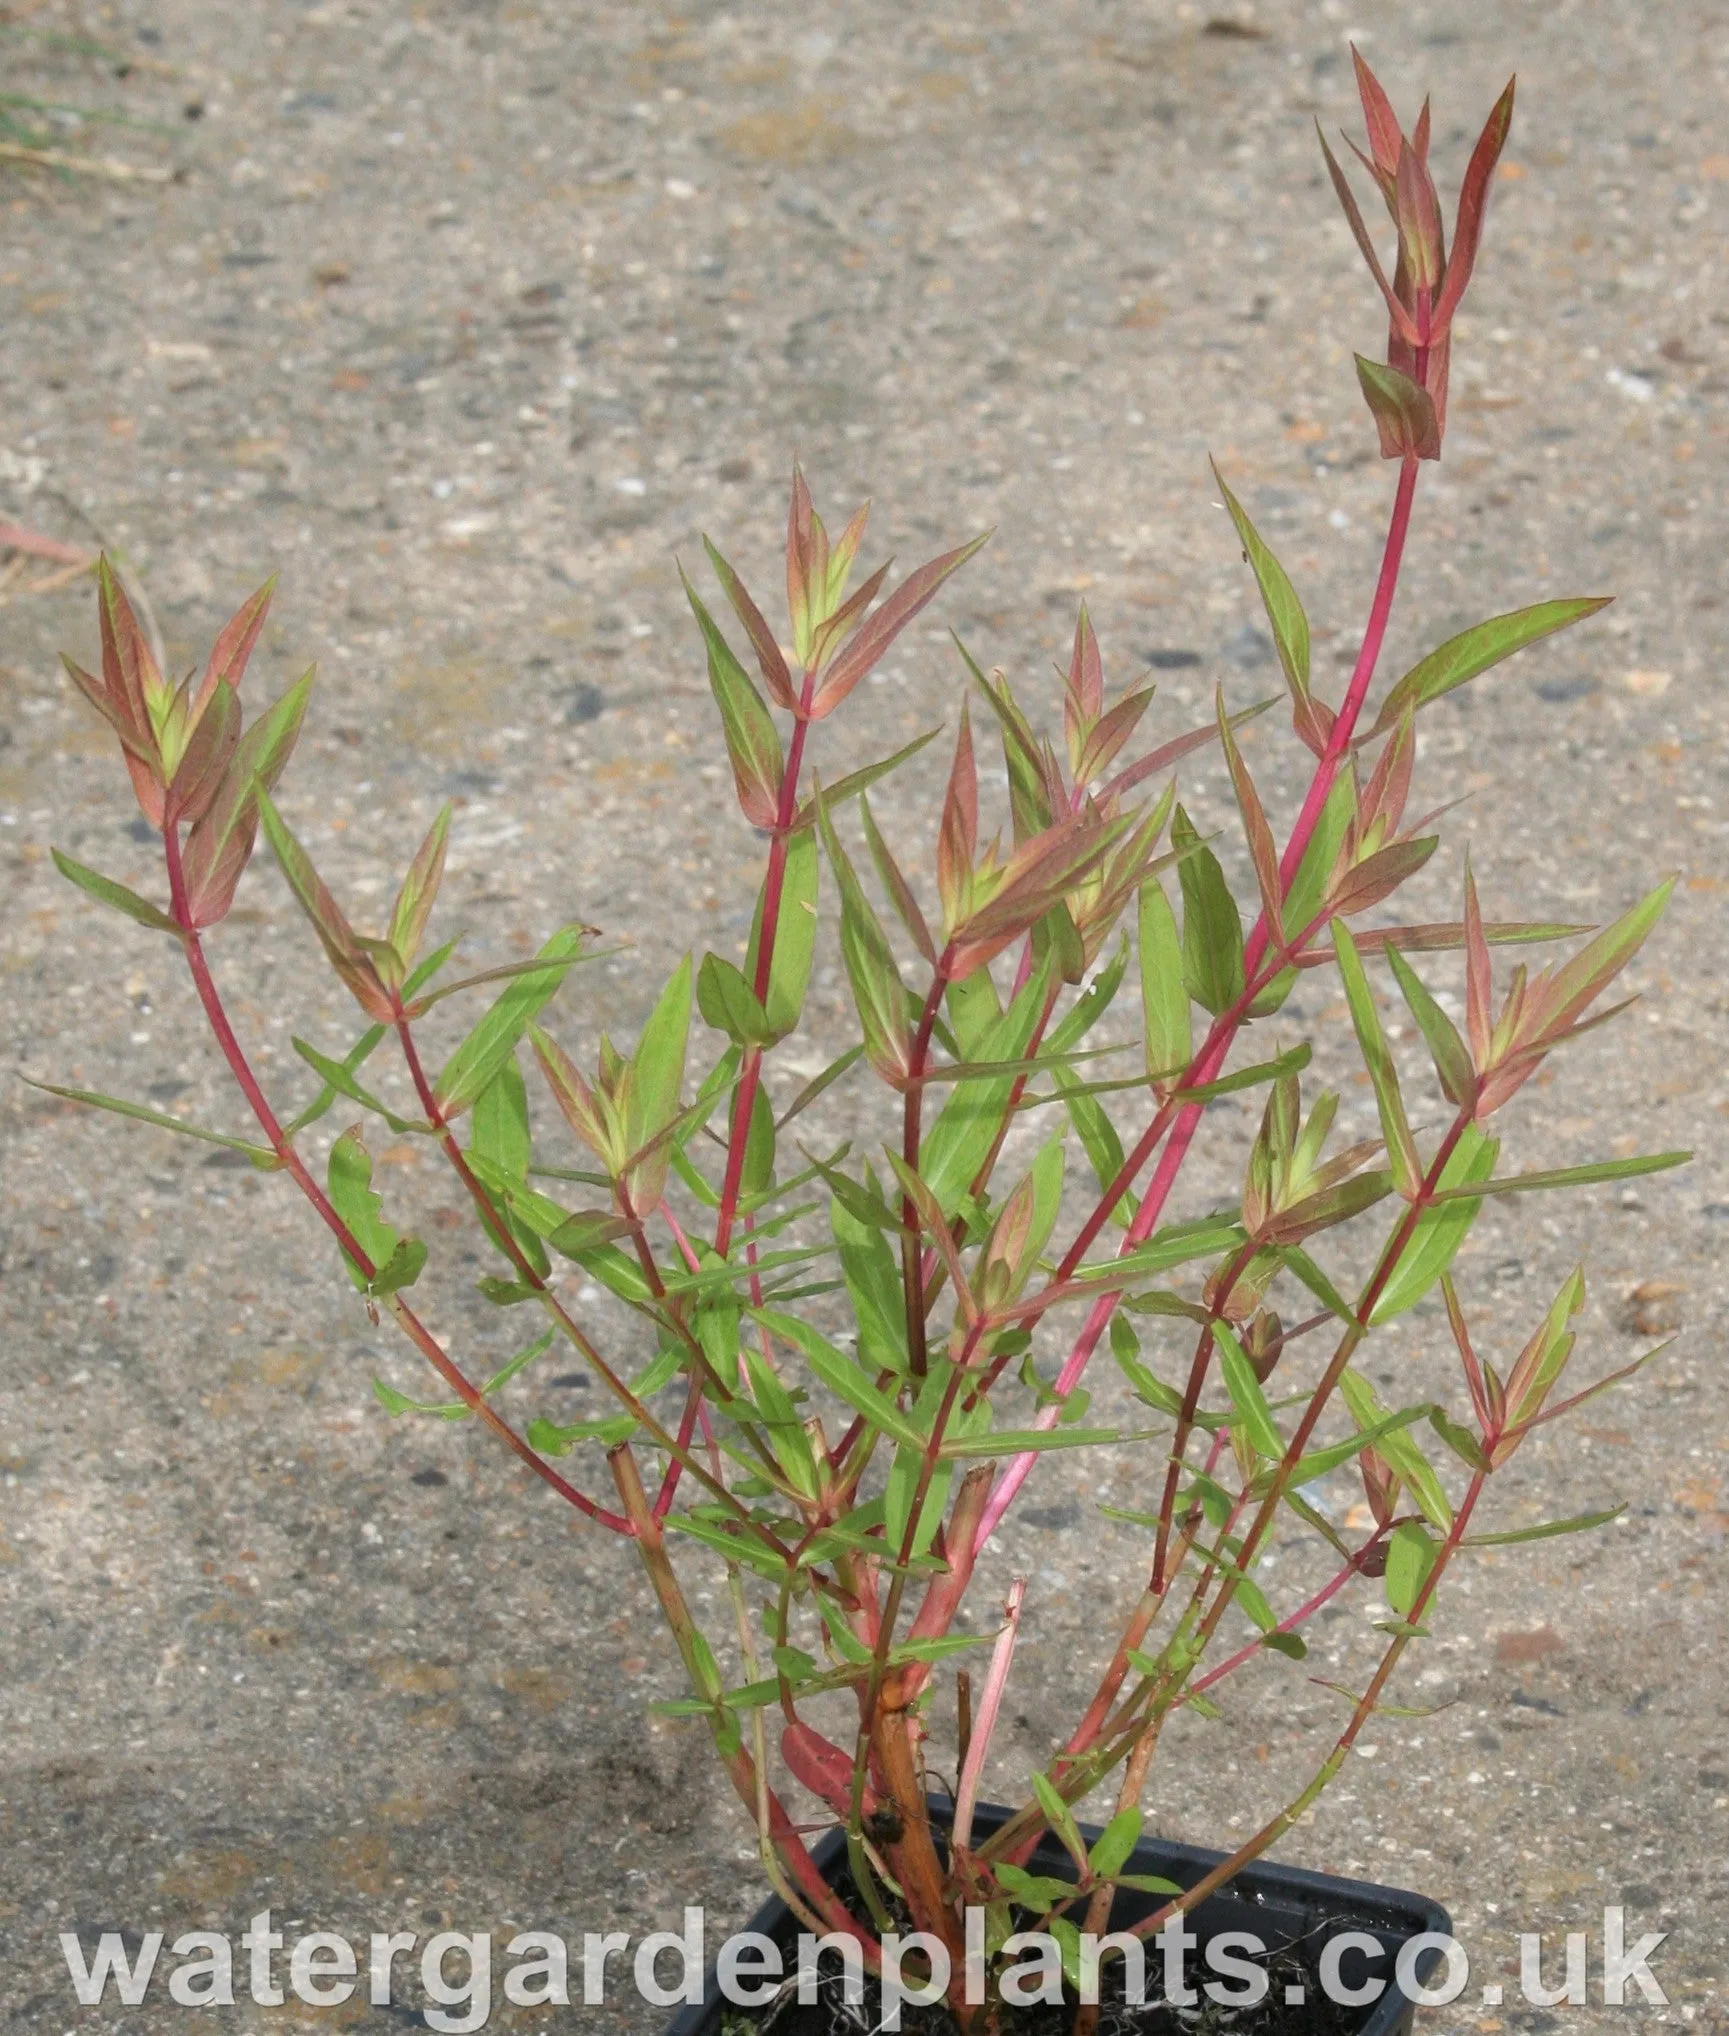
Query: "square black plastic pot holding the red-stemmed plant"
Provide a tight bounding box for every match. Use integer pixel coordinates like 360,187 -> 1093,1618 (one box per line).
666,1798 -> 1452,2036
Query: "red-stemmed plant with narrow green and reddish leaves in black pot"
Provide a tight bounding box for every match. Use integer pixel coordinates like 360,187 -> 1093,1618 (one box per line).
37,59 -> 1684,2036
